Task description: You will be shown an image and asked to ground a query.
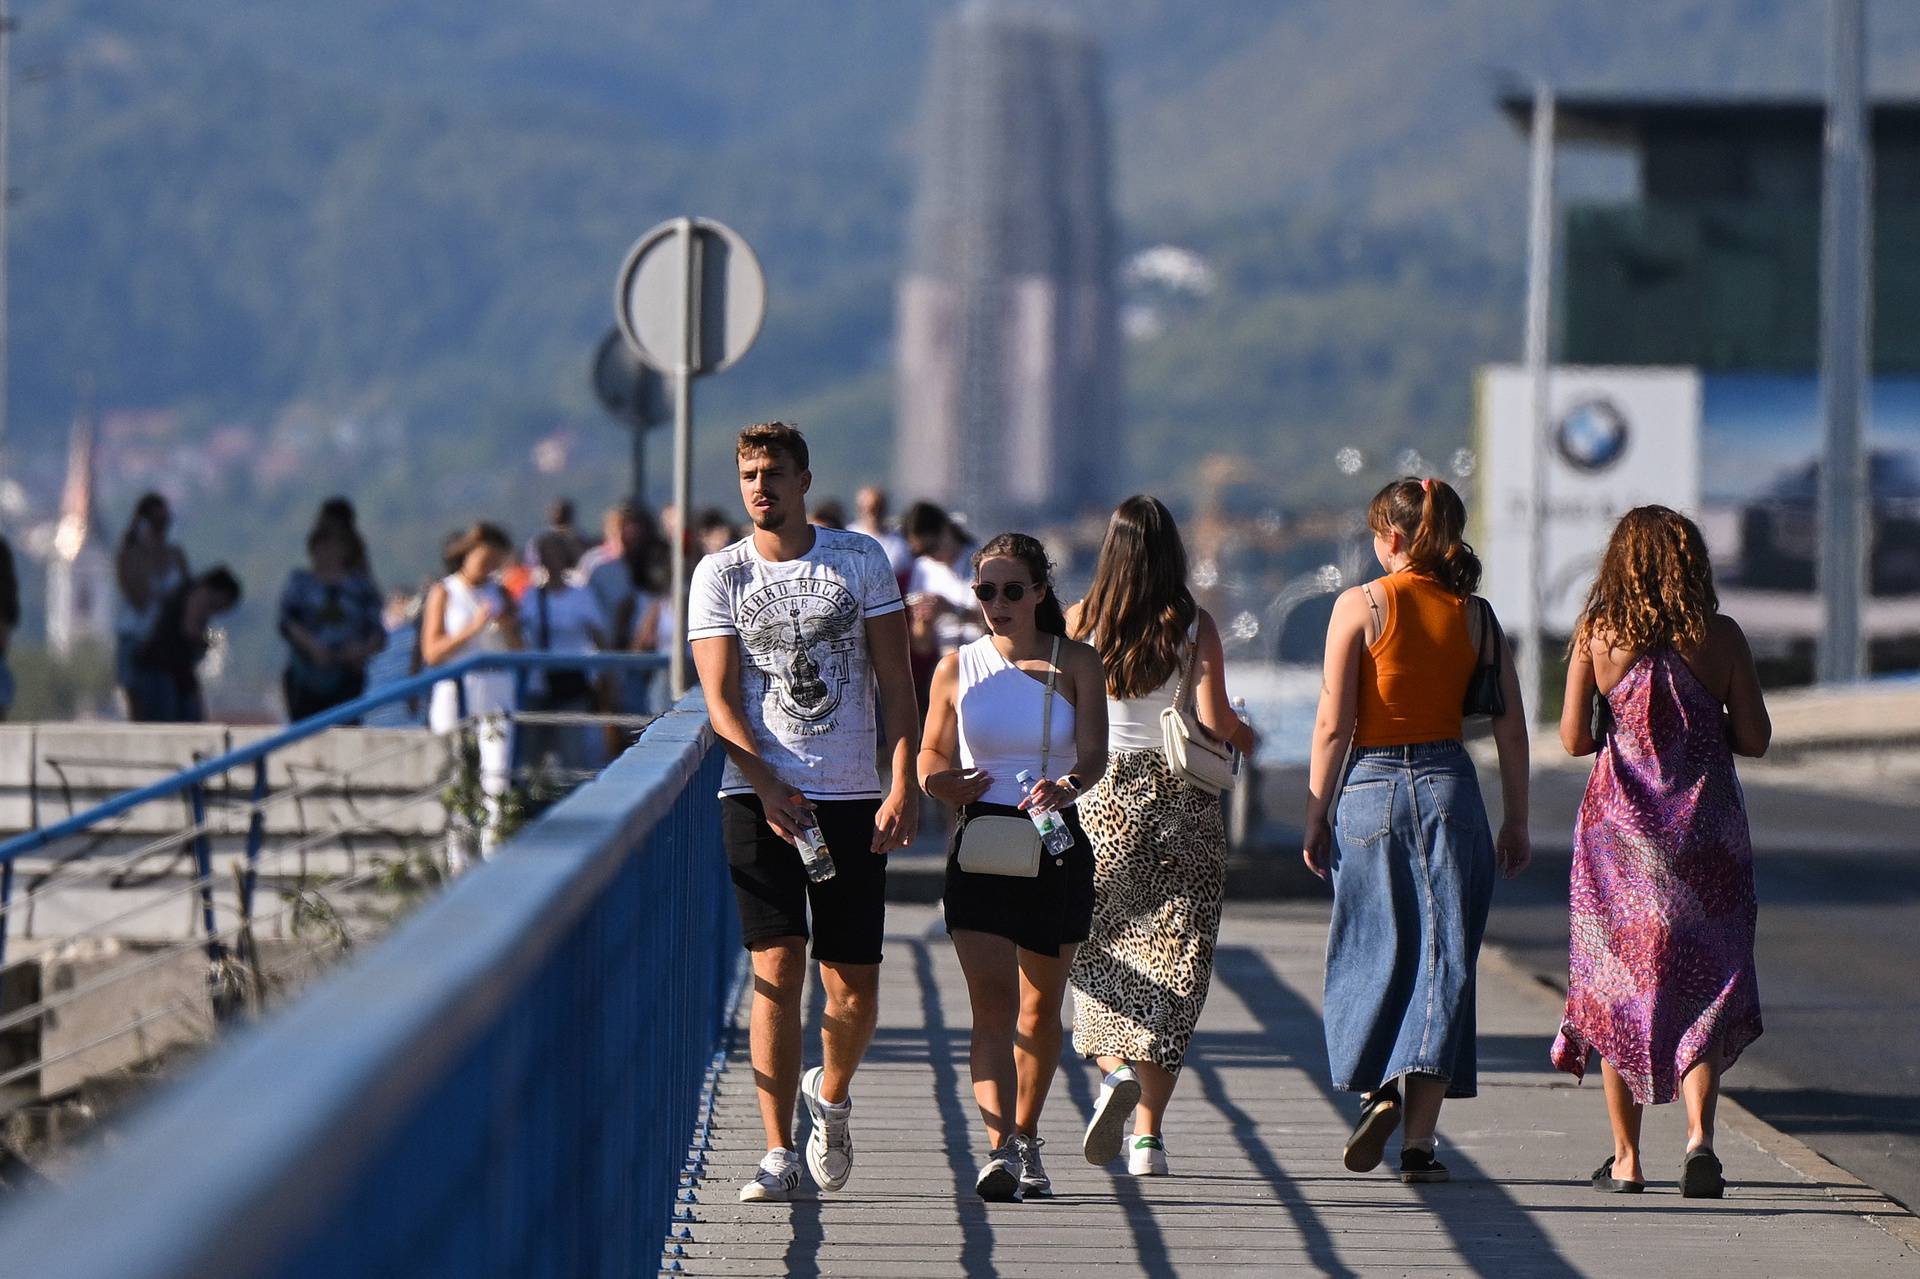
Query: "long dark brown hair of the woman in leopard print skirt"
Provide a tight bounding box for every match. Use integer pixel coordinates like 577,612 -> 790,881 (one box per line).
1075,494 -> 1200,697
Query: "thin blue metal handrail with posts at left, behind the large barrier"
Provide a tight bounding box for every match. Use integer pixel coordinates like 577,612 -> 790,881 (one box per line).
0,653 -> 666,964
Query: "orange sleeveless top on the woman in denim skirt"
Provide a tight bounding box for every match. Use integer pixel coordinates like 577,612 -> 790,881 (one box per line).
1354,570 -> 1476,747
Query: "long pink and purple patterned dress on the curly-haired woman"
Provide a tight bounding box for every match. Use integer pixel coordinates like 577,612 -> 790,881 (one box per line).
1553,651 -> 1761,1104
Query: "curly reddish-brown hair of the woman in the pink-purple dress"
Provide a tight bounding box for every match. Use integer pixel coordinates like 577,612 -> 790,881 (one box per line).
1572,507 -> 1720,653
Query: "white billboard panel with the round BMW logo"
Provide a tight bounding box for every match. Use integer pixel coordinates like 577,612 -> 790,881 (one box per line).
1473,365 -> 1701,640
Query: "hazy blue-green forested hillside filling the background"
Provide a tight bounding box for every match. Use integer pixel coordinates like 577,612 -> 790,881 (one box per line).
6,0 -> 1920,706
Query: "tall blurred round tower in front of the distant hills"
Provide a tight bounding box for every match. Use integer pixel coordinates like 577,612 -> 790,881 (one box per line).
895,4 -> 1123,536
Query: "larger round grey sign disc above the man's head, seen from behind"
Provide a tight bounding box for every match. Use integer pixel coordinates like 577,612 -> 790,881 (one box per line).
614,217 -> 766,376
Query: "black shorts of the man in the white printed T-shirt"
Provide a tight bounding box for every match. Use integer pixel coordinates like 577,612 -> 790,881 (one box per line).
720,795 -> 887,964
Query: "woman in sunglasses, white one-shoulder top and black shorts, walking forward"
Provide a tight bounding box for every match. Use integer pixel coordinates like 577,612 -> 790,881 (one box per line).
920,534 -> 1106,1200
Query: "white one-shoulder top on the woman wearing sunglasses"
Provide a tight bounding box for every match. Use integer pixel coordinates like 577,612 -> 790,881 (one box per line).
956,636 -> 1075,805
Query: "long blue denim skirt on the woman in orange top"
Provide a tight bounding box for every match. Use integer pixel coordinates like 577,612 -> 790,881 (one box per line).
1325,741 -> 1494,1097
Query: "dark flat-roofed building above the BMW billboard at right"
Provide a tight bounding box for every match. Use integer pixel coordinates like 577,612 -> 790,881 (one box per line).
1500,92 -> 1920,374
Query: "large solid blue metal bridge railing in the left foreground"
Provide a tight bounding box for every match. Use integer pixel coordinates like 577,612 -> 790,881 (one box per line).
0,693 -> 743,1279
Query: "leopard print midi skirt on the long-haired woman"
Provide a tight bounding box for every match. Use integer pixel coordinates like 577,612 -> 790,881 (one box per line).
1073,751 -> 1227,1070
